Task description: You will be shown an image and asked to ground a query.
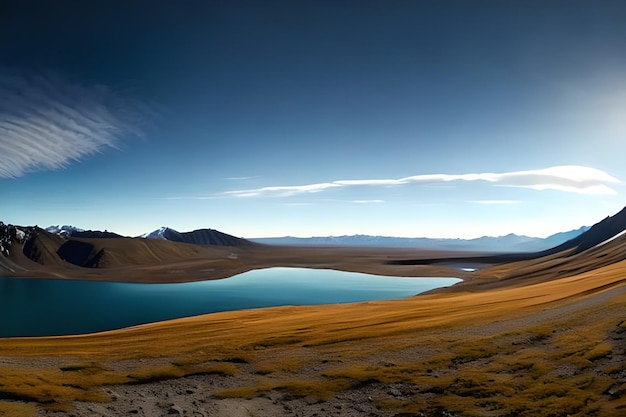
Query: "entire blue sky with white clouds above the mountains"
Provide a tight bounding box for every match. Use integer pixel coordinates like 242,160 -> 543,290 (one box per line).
0,0 -> 626,238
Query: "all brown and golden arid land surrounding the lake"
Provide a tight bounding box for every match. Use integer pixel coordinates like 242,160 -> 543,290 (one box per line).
0,213 -> 626,417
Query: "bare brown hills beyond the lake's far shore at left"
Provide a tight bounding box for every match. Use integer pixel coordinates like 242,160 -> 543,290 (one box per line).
0,228 -> 250,282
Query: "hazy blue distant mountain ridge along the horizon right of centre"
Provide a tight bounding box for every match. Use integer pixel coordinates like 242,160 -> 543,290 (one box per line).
249,226 -> 589,252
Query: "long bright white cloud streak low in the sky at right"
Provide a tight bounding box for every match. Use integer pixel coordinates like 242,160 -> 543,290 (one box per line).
224,165 -> 620,197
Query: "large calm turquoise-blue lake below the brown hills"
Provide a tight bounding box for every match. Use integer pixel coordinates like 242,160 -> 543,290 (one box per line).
0,268 -> 460,337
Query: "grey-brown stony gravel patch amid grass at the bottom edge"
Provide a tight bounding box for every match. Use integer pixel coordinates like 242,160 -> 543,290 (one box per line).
42,376 -> 454,417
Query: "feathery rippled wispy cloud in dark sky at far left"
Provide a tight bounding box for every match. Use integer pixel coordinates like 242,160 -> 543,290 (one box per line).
0,69 -> 151,178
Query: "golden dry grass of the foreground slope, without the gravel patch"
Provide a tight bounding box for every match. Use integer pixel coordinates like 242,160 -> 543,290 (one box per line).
0,247 -> 626,416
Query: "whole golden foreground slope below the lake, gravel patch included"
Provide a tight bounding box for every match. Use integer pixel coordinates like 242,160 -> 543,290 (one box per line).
0,262 -> 626,417
